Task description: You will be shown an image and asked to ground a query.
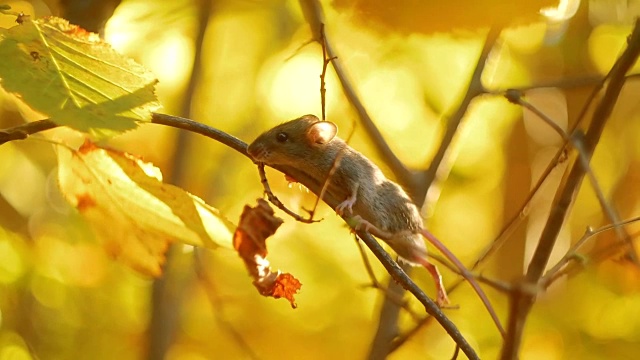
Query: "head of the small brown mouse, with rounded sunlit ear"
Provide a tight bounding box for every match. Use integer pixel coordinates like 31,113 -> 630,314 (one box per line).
247,115 -> 338,166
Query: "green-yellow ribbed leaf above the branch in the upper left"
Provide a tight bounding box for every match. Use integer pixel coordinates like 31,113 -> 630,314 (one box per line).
0,17 -> 159,138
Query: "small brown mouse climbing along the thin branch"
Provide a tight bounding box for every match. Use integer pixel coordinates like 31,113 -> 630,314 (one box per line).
247,115 -> 449,306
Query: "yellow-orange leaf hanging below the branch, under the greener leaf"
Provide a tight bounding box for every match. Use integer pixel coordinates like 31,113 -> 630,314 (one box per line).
58,142 -> 234,276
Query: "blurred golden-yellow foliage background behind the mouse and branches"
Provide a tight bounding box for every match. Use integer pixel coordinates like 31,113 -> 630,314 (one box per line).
0,0 -> 640,360
